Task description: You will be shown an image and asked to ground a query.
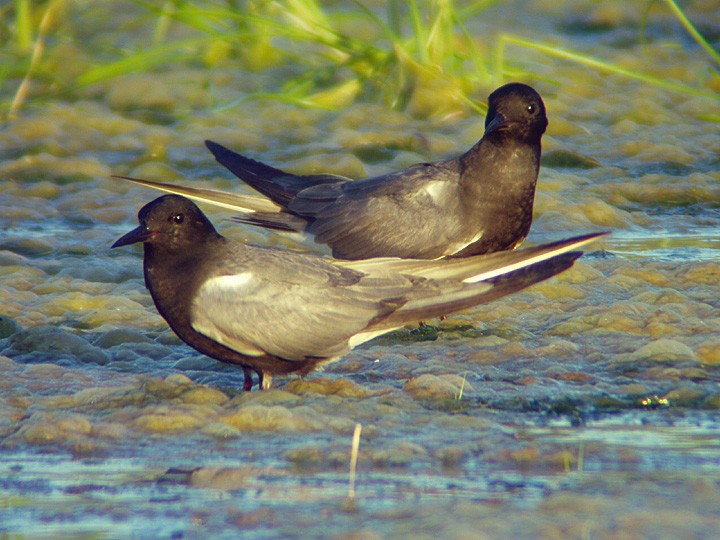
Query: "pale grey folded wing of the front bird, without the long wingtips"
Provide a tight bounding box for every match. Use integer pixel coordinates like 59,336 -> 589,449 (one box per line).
191,252 -> 412,361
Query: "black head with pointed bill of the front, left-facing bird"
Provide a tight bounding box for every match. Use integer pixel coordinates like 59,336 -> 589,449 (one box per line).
112,195 -> 220,251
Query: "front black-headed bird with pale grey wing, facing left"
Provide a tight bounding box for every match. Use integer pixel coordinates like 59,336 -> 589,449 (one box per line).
112,195 -> 602,390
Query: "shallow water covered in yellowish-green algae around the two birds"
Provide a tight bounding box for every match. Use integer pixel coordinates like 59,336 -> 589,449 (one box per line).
0,1 -> 720,538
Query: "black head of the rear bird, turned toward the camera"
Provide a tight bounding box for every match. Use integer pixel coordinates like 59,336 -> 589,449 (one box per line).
485,83 -> 548,143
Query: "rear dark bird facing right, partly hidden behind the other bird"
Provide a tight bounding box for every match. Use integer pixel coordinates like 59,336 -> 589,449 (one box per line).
115,83 -> 548,260
